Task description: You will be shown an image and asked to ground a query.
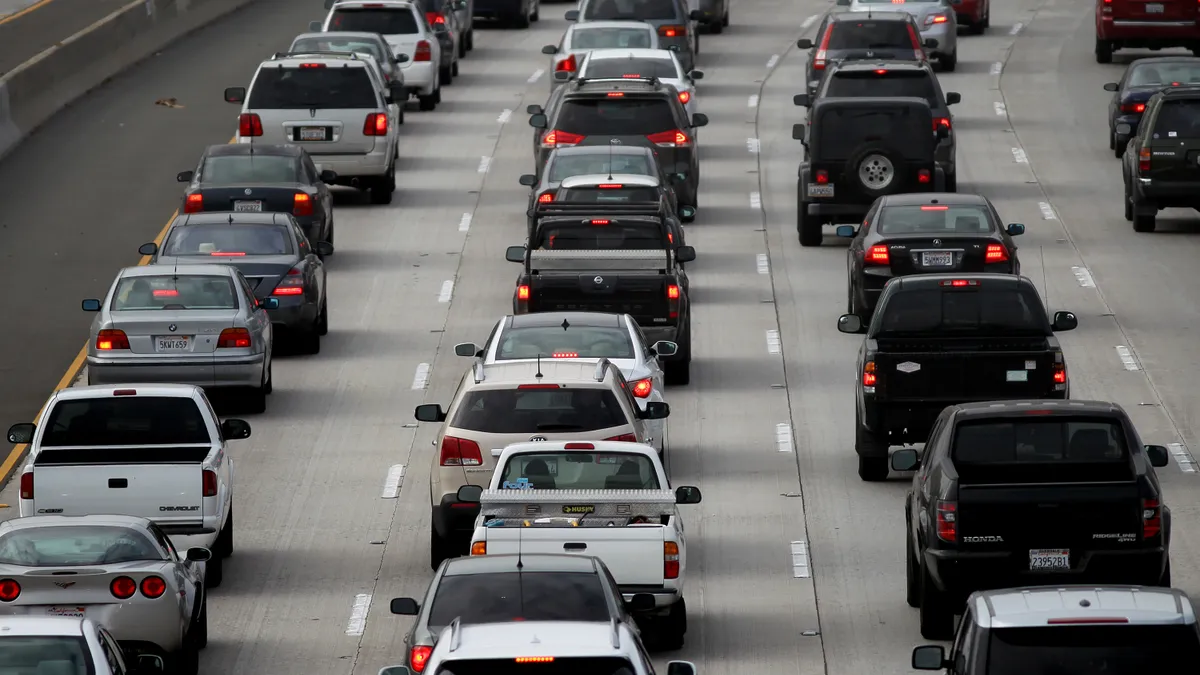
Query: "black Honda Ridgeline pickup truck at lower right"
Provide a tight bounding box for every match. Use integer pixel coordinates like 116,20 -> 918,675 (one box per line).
892,400 -> 1171,640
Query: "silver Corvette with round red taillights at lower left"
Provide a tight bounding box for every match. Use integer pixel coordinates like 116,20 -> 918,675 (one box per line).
0,515 -> 211,675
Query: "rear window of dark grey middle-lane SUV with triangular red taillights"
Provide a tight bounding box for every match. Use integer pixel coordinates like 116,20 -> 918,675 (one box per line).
556,96 -> 676,136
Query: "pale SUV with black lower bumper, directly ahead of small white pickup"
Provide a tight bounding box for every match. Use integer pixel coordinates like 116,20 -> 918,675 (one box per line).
415,359 -> 671,569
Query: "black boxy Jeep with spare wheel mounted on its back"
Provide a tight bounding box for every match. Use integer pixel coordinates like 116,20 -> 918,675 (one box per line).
792,97 -> 949,246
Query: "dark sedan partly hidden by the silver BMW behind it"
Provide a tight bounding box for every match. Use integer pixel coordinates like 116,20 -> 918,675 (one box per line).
138,213 -> 334,354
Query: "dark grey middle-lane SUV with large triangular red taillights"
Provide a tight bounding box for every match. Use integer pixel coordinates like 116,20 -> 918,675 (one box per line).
526,73 -> 708,209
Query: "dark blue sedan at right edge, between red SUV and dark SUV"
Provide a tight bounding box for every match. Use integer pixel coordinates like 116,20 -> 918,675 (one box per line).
1104,56 -> 1200,159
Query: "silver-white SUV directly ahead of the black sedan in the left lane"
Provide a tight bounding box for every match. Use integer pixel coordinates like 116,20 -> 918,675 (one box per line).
224,53 -> 404,204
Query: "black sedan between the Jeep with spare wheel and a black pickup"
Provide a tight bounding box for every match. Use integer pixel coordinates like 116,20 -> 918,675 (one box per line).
838,192 -> 1025,324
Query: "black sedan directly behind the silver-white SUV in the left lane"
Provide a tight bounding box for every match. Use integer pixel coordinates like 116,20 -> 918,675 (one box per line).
175,143 -> 337,244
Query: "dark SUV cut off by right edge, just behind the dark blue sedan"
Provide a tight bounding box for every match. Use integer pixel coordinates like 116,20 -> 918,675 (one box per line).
1116,86 -> 1200,232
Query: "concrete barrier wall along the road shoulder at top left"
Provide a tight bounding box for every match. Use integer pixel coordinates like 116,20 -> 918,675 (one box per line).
0,0 -> 253,161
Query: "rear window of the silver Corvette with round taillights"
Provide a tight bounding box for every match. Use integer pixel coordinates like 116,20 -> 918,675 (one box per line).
0,525 -> 162,564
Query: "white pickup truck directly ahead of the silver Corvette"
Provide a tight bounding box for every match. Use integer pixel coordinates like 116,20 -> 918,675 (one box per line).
8,384 -> 250,589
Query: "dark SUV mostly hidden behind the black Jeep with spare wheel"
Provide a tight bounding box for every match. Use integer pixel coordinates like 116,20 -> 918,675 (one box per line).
792,60 -> 962,192
